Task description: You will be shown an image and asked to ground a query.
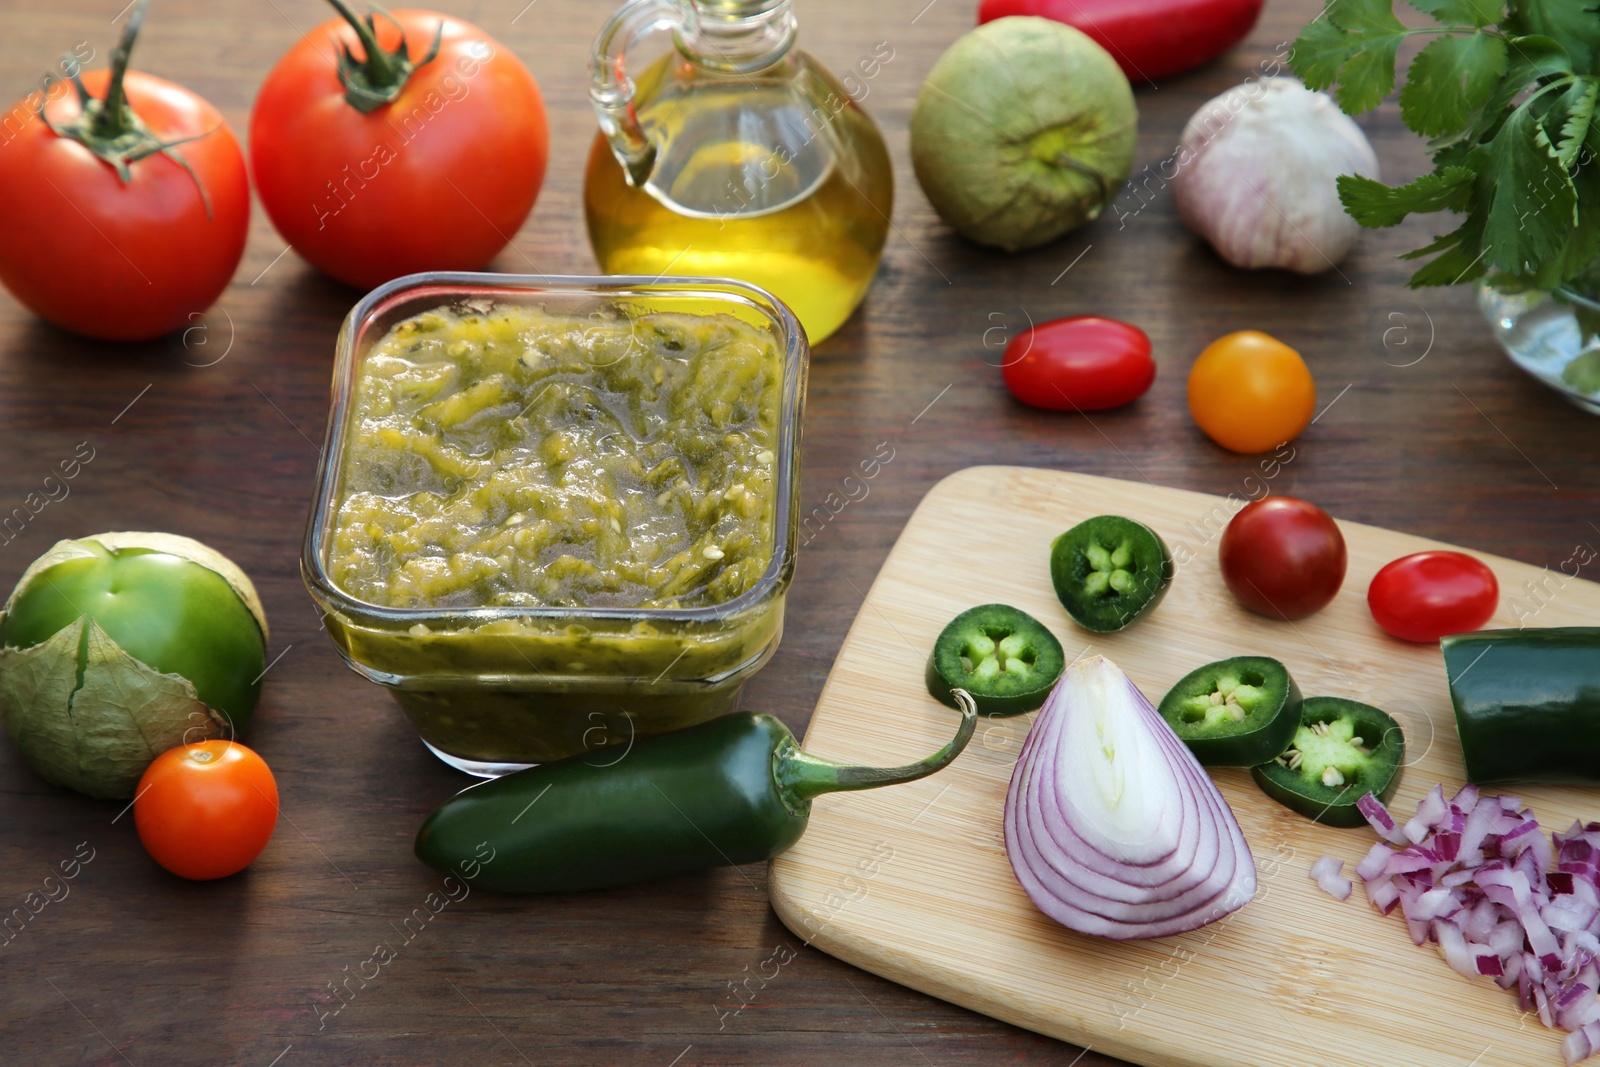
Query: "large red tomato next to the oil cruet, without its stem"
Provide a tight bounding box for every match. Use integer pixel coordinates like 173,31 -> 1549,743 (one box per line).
250,11 -> 549,288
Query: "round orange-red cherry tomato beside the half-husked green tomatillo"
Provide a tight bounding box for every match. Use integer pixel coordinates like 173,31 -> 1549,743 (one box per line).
133,741 -> 278,881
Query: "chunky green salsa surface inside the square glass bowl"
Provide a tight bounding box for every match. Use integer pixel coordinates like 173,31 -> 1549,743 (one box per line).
328,304 -> 782,611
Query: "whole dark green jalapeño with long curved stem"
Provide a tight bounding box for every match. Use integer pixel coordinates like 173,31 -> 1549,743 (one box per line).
416,693 -> 978,893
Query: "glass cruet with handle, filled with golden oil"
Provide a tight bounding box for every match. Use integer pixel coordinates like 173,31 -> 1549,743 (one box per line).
584,0 -> 894,344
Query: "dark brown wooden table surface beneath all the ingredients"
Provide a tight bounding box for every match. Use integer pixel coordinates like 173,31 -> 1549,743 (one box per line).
0,0 -> 1600,1067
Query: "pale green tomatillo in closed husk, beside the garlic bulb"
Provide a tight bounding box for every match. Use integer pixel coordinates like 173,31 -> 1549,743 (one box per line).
910,16 -> 1139,251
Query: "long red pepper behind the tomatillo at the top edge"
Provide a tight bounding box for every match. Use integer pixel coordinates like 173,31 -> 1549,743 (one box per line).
978,0 -> 1262,82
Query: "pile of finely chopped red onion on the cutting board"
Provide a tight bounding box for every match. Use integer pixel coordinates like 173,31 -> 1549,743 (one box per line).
1356,784 -> 1600,1064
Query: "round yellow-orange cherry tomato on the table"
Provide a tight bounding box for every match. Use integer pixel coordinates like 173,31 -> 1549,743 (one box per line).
1189,330 -> 1317,453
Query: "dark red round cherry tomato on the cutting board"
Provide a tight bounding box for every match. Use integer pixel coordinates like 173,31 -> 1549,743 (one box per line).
1221,496 -> 1346,619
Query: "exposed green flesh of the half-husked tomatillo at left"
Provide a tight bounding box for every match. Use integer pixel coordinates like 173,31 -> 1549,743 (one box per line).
0,539 -> 267,734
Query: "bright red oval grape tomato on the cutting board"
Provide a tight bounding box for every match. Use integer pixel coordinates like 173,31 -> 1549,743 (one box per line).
1366,552 -> 1499,641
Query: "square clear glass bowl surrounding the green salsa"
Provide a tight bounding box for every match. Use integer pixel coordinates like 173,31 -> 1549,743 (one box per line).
301,272 -> 810,777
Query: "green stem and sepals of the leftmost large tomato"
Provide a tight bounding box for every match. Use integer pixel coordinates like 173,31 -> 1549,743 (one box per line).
37,0 -> 221,219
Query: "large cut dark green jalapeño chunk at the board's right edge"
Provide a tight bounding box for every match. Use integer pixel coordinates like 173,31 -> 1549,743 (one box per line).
1438,625 -> 1600,784
